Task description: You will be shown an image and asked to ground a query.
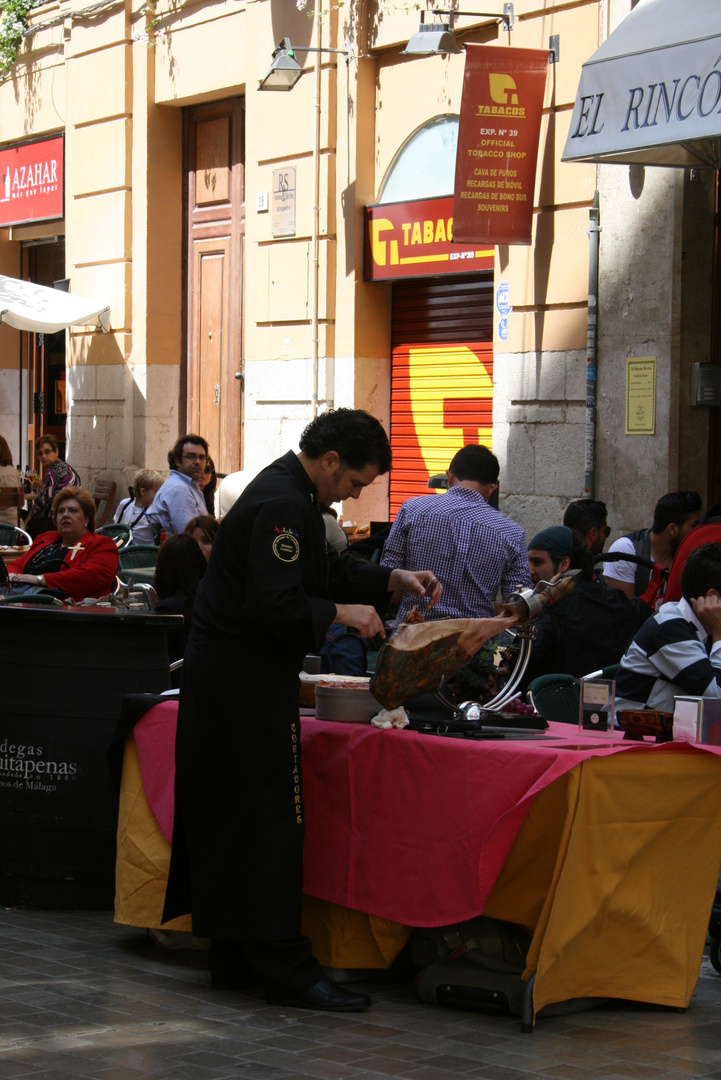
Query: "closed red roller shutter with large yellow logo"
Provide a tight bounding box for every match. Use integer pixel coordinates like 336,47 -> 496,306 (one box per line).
391,274 -> 493,518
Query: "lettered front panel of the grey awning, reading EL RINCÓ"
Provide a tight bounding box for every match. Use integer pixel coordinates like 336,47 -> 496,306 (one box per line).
562,36 -> 721,164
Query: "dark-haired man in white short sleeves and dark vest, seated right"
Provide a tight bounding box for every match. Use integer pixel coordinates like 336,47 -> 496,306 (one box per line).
603,491 -> 700,596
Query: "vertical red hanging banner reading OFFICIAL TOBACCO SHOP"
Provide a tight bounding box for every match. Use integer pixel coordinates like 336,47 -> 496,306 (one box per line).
453,44 -> 548,244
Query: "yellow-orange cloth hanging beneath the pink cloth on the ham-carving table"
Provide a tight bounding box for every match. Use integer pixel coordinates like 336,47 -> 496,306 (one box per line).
115,738 -> 721,1012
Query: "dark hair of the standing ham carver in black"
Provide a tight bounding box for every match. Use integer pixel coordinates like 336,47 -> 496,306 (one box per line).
299,408 -> 391,473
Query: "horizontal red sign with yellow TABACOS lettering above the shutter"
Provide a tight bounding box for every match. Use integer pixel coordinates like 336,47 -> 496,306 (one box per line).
364,195 -> 493,281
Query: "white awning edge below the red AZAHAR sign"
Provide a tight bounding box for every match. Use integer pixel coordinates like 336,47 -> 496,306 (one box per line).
0,274 -> 110,334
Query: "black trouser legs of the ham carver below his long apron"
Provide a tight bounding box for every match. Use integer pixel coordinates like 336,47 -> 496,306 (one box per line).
210,935 -> 323,997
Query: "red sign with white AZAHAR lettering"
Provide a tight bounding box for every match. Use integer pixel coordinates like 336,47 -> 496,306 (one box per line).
0,135 -> 64,227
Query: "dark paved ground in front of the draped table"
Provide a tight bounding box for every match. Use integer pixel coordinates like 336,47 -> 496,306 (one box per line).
0,909 -> 721,1080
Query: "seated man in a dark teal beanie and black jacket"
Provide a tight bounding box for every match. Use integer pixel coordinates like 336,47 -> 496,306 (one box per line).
523,525 -> 653,688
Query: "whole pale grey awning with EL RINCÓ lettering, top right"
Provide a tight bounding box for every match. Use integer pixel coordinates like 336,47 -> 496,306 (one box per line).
562,0 -> 721,168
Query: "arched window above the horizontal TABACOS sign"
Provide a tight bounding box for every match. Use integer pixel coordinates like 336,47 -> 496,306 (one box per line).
378,113 -> 459,203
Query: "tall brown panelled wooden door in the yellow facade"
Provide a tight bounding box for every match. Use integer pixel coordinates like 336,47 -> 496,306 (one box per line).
185,98 -> 245,473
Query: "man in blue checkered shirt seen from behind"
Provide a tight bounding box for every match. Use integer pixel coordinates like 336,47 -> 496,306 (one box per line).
381,445 -> 531,622
